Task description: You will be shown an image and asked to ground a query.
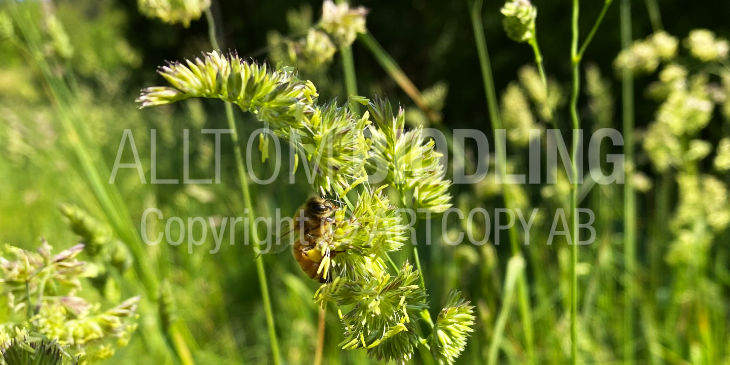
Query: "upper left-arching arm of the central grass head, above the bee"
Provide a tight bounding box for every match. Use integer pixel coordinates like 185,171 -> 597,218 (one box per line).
137,51 -> 369,194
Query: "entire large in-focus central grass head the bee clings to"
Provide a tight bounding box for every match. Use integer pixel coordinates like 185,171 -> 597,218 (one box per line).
138,51 -> 474,363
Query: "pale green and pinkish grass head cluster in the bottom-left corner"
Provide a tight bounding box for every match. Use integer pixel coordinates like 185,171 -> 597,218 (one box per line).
0,241 -> 139,364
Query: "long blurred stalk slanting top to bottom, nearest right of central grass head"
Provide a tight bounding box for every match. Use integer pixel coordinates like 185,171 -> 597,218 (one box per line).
470,0 -> 535,363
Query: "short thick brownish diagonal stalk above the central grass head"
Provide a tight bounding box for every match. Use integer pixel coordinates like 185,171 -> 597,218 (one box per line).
357,33 -> 441,122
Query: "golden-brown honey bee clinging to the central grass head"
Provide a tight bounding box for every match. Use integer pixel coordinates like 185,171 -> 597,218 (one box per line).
292,197 -> 338,283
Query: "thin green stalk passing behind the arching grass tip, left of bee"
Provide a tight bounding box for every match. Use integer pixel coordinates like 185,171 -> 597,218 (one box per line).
205,8 -> 281,365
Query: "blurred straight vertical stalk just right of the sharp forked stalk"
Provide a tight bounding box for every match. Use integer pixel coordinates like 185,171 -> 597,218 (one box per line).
620,0 -> 636,364
